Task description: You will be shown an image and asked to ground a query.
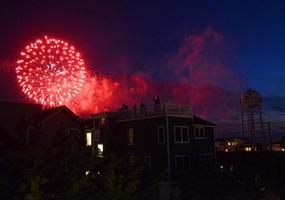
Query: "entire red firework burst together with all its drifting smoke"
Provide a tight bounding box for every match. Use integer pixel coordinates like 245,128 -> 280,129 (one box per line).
16,29 -> 240,122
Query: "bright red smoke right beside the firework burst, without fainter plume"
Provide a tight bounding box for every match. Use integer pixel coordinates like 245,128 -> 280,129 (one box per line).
67,71 -> 155,116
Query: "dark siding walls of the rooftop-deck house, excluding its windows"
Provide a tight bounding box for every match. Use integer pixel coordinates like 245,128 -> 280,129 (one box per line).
87,115 -> 215,178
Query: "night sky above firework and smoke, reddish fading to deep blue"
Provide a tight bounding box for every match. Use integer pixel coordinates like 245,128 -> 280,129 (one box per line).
0,0 -> 285,96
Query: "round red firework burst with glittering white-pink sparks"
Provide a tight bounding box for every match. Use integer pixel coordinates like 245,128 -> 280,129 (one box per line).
16,36 -> 86,106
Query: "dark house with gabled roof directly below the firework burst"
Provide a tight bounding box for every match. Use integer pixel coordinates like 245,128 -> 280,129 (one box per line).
0,102 -> 83,155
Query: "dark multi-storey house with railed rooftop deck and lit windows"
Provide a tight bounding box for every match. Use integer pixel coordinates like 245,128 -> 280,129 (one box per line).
86,102 -> 215,180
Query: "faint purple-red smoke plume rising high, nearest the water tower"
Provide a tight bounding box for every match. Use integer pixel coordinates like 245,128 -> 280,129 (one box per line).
166,28 -> 240,118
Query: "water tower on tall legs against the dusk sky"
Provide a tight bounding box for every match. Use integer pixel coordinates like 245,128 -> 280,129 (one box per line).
240,89 -> 265,144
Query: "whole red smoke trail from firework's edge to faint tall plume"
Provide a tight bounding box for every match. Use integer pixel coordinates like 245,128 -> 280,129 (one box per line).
71,28 -> 240,122
